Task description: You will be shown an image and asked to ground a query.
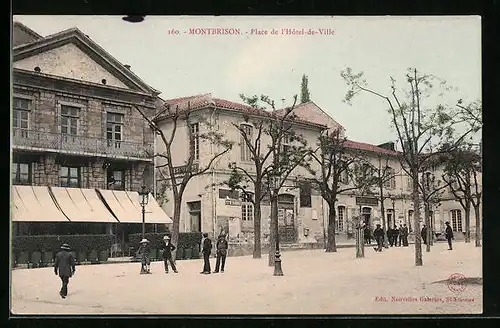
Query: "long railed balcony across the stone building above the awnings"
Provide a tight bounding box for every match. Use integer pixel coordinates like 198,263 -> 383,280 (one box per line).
12,129 -> 153,160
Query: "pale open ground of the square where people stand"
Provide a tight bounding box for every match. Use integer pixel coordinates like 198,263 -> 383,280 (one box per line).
11,243 -> 483,315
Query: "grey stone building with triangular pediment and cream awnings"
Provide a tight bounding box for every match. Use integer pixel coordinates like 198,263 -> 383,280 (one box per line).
12,22 -> 171,247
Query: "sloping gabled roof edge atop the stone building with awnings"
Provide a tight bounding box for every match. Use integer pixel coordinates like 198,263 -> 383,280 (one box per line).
12,23 -> 161,95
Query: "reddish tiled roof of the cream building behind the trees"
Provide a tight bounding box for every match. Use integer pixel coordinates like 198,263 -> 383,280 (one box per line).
157,93 -> 326,128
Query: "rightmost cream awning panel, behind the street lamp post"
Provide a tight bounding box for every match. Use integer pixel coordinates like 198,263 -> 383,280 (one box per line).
98,189 -> 172,224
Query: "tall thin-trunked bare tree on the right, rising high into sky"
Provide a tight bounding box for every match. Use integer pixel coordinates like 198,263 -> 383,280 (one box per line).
341,68 -> 475,266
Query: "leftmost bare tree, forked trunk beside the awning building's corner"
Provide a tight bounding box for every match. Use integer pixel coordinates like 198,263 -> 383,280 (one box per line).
135,102 -> 232,259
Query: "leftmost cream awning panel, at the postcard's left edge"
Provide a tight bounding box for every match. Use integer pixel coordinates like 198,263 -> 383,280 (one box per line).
11,186 -> 68,222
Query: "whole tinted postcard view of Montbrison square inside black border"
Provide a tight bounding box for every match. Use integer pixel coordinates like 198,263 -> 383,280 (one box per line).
9,16 -> 484,315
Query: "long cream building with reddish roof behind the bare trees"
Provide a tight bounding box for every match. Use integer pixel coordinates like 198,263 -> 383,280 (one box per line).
156,94 -> 480,245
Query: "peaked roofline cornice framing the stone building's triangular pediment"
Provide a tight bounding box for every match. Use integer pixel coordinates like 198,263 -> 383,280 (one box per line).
12,27 -> 161,96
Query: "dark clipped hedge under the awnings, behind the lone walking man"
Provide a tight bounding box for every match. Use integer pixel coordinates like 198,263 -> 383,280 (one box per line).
12,234 -> 114,254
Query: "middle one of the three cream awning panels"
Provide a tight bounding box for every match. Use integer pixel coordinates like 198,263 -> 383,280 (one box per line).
50,187 -> 118,223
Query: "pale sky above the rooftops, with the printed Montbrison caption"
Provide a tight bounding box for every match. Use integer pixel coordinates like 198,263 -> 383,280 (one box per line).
14,16 -> 481,144
